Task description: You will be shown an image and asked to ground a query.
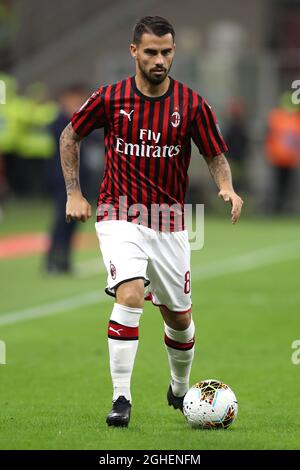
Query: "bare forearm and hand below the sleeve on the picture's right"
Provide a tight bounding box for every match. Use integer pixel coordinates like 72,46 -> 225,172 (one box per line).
204,153 -> 244,224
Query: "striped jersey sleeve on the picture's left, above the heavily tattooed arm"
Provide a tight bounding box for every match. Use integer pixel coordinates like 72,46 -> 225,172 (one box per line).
71,87 -> 106,137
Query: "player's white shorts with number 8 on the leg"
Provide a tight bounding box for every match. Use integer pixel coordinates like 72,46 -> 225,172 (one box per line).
95,220 -> 192,313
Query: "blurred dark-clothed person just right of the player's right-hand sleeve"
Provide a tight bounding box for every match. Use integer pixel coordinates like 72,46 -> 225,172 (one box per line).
224,99 -> 249,192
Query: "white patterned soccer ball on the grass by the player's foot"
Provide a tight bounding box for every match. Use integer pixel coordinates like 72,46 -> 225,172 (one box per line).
183,379 -> 238,429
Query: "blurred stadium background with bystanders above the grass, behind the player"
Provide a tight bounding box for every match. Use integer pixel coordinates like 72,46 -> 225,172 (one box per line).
0,0 -> 300,271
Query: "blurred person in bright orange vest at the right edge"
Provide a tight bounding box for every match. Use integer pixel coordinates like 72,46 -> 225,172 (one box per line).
265,91 -> 300,213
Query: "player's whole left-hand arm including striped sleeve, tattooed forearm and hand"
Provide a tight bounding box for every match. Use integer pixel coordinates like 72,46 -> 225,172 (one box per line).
60,88 -> 106,222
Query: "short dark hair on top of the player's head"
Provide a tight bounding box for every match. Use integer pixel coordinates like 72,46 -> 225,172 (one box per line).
133,16 -> 175,44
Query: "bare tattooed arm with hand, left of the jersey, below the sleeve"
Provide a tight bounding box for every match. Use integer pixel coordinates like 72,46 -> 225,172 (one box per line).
59,123 -> 92,222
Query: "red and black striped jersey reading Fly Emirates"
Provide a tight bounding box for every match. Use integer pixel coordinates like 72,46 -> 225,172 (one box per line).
72,77 -> 227,231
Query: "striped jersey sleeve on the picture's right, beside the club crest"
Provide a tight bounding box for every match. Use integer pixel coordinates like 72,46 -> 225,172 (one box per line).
192,97 -> 228,157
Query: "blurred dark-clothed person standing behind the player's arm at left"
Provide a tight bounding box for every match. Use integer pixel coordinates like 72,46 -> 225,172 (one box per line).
45,85 -> 89,274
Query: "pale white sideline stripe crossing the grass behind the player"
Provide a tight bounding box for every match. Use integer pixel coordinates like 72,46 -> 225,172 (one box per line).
0,241 -> 300,325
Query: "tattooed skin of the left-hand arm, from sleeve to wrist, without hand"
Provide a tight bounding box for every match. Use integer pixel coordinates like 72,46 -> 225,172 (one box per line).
59,123 -> 81,195
